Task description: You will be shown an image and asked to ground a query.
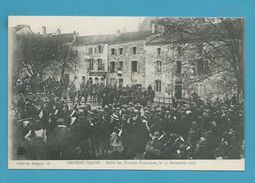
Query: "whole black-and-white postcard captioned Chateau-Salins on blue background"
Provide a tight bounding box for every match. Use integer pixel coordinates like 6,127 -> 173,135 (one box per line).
8,16 -> 245,171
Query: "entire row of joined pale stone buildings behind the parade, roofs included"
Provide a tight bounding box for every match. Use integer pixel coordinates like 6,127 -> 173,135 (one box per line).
71,18 -> 241,98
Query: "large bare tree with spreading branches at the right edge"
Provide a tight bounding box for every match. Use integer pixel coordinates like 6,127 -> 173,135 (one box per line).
159,18 -> 244,98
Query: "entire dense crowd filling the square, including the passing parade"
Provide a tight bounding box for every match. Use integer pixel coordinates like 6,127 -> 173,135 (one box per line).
12,76 -> 244,160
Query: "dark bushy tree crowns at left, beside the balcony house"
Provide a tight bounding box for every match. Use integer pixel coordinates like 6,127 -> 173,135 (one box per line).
13,35 -> 78,79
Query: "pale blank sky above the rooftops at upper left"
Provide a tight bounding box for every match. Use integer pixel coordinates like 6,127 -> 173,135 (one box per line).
9,16 -> 144,36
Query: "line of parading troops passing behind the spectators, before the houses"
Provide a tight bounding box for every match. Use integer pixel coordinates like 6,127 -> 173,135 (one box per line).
14,76 -> 155,107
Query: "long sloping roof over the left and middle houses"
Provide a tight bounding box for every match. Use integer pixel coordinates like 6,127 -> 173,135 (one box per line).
75,31 -> 151,45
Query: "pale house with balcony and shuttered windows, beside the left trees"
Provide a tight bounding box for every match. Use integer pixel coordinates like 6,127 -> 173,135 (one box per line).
74,35 -> 112,86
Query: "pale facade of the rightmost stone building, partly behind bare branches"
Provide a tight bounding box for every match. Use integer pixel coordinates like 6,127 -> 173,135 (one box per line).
145,36 -> 209,98
